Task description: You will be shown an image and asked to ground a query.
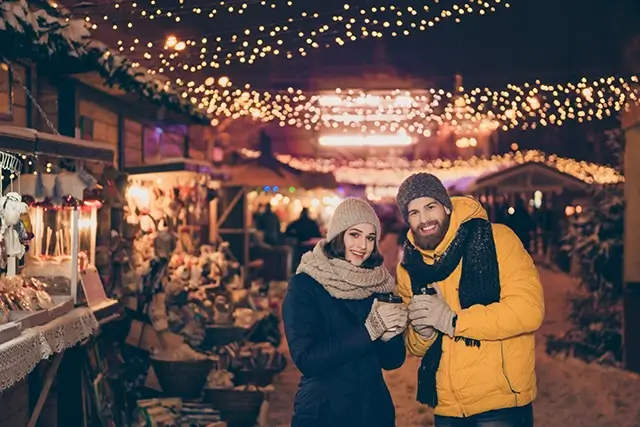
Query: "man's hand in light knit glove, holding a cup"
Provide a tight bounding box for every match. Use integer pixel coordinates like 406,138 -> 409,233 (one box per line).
409,295 -> 456,338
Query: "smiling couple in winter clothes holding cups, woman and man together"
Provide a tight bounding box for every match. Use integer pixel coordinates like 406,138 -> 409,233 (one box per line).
283,173 -> 544,427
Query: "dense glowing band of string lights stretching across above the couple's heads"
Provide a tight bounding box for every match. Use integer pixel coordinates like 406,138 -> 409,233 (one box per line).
178,76 -> 639,135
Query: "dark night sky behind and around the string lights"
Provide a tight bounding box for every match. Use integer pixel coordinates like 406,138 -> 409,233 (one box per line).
77,0 -> 640,160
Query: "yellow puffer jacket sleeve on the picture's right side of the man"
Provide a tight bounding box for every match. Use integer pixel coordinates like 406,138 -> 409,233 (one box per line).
455,224 -> 544,341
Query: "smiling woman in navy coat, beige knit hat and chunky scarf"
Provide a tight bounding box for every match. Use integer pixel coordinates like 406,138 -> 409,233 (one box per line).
282,198 -> 408,427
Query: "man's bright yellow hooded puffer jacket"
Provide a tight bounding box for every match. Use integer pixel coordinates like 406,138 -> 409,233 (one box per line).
397,197 -> 544,417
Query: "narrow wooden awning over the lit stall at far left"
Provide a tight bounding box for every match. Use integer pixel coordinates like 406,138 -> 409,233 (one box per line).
0,126 -> 115,164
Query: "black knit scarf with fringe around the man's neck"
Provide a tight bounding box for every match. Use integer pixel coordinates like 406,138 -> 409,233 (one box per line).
401,219 -> 500,408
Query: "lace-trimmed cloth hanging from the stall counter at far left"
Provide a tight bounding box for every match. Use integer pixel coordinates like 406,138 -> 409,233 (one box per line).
0,307 -> 99,392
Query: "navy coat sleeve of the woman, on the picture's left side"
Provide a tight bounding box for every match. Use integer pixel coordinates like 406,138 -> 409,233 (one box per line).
282,276 -> 374,377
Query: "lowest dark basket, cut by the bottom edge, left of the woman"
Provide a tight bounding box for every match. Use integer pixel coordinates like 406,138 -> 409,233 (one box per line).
204,389 -> 264,427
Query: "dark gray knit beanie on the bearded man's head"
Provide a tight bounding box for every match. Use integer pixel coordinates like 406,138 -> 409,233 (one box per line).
396,172 -> 453,224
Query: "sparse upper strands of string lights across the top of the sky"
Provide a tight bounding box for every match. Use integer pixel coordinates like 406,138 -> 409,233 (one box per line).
85,0 -> 509,68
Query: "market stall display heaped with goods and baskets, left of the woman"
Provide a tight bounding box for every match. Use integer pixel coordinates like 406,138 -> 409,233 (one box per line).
120,219 -> 284,426
